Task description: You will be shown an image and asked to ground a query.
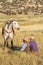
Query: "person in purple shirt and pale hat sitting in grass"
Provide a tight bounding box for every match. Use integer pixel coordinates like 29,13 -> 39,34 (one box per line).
29,36 -> 38,52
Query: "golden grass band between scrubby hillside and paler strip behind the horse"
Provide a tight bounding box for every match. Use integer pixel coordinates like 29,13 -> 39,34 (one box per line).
0,14 -> 43,26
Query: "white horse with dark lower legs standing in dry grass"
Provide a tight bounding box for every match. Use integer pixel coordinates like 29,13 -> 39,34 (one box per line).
2,21 -> 20,47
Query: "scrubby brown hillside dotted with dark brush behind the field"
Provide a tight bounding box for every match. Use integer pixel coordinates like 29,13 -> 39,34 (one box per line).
0,0 -> 43,15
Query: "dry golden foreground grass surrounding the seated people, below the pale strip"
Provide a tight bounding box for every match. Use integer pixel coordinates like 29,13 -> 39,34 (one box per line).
0,32 -> 43,65
